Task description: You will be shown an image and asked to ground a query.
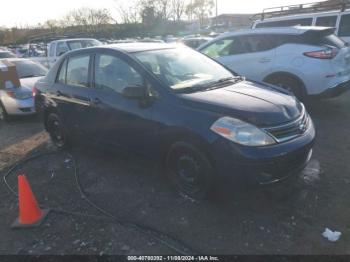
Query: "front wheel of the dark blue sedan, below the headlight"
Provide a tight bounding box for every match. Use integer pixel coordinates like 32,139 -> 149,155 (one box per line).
165,142 -> 214,200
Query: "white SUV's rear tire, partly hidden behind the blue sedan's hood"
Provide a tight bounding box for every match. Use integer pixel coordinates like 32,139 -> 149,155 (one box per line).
265,74 -> 306,101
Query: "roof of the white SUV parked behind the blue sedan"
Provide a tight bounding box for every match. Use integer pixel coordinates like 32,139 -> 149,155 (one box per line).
219,26 -> 330,38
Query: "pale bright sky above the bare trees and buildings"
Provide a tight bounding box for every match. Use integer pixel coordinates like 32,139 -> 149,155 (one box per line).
0,0 -> 326,27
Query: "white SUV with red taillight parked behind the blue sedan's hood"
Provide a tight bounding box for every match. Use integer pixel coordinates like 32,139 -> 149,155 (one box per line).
198,27 -> 350,100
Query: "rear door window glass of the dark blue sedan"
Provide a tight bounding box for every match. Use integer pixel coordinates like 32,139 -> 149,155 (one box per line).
67,55 -> 90,87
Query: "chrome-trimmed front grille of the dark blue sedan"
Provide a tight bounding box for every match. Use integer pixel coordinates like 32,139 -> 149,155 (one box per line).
264,106 -> 310,143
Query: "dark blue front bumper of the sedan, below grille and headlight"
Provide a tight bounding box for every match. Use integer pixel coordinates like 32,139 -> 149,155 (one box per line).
212,119 -> 316,185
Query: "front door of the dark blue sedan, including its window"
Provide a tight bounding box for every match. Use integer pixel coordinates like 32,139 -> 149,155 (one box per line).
93,51 -> 155,153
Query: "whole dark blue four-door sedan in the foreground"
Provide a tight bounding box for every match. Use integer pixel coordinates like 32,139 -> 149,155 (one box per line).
35,43 -> 315,198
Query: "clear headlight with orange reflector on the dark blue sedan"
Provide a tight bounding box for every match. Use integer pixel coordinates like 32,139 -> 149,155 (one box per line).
210,116 -> 276,146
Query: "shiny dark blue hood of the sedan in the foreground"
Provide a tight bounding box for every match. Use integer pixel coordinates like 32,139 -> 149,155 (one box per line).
179,81 -> 302,127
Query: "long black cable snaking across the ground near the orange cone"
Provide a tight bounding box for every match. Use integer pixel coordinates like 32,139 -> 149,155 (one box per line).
3,151 -> 198,255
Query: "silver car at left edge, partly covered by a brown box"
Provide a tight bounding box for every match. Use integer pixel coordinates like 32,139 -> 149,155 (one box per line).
0,58 -> 47,121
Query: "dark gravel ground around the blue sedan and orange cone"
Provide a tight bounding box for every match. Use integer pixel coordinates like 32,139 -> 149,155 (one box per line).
0,93 -> 350,254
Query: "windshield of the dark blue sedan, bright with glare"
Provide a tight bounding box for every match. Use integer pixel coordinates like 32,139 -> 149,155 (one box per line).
134,47 -> 236,92
